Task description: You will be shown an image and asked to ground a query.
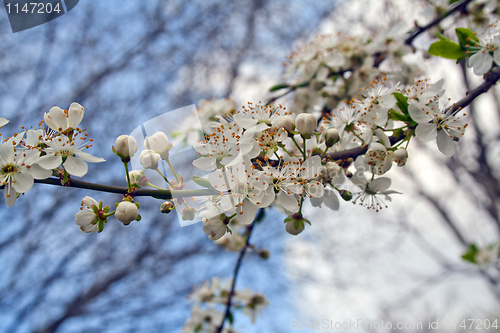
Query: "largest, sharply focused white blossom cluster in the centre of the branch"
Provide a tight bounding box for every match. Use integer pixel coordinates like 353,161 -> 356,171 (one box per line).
188,80 -> 467,233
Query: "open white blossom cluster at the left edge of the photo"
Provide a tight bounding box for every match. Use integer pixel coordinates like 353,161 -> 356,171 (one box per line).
0,103 -> 104,207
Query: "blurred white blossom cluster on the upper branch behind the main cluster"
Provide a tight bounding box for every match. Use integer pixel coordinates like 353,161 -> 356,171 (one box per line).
286,25 -> 421,114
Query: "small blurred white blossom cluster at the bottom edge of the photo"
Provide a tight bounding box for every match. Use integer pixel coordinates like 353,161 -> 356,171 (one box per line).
182,278 -> 269,333
